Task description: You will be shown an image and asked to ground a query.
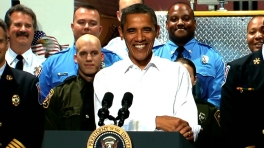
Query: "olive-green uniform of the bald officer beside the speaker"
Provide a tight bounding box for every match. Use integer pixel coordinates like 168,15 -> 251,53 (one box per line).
42,75 -> 95,131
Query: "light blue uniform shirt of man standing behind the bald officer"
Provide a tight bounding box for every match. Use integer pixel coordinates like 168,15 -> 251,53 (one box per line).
39,45 -> 121,102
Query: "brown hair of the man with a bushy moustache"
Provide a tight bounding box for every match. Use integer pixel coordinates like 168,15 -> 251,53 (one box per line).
5,4 -> 37,30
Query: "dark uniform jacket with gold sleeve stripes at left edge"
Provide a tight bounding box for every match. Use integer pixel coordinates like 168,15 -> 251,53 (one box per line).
0,63 -> 44,148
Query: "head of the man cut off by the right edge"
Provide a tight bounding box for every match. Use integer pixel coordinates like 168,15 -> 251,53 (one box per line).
247,15 -> 264,52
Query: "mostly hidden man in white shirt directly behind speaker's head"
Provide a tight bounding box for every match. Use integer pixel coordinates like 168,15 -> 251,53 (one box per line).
104,0 -> 161,59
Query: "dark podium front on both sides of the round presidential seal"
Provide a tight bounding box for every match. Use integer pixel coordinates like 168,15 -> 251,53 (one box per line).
42,131 -> 193,148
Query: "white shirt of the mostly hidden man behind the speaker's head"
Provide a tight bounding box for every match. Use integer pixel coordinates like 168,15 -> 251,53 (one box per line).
104,37 -> 161,59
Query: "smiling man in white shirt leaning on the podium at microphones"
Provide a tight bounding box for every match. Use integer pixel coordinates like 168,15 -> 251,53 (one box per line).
94,4 -> 198,141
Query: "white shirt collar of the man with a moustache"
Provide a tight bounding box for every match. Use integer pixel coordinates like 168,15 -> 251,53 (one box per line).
6,48 -> 34,64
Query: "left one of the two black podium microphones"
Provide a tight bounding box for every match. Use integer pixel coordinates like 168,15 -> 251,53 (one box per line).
97,92 -> 114,126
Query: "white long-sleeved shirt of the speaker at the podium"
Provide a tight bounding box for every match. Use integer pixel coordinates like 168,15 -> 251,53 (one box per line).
94,55 -> 199,139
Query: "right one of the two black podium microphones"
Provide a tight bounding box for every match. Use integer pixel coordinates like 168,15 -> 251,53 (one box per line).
116,92 -> 133,127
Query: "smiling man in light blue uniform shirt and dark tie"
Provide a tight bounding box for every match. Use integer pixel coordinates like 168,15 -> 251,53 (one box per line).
153,2 -> 225,108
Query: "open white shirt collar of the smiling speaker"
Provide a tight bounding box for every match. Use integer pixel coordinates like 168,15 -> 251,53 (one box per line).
121,53 -> 158,73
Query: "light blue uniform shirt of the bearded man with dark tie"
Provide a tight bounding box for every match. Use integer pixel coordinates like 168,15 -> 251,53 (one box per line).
153,38 -> 225,108
